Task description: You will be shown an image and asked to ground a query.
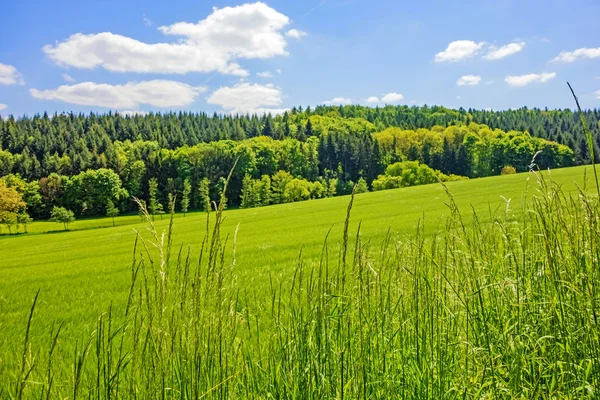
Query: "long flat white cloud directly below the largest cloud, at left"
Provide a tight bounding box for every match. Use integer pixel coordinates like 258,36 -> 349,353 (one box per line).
29,80 -> 206,109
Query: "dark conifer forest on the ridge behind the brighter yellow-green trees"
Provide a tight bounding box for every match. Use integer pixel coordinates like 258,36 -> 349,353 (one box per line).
0,105 -> 600,179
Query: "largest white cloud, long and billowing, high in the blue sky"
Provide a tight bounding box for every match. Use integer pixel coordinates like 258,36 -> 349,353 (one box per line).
43,2 -> 290,76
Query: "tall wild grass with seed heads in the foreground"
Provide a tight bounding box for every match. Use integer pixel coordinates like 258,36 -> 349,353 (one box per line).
0,104 -> 600,399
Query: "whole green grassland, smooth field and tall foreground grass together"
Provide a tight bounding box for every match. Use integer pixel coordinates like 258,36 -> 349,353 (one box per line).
0,168 -> 600,398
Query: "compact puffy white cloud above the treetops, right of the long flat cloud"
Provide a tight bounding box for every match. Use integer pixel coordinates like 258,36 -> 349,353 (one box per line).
206,82 -> 286,114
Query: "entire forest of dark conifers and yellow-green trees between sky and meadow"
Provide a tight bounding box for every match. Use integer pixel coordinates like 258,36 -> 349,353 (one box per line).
0,105 -> 600,227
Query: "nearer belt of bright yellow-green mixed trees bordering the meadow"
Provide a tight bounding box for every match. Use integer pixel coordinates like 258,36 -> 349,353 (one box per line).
0,114 -> 575,233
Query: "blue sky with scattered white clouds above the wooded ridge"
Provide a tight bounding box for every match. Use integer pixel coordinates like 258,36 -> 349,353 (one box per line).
0,0 -> 600,117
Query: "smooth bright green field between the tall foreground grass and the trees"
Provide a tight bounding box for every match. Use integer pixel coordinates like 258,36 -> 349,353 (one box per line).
0,167 -> 597,397
